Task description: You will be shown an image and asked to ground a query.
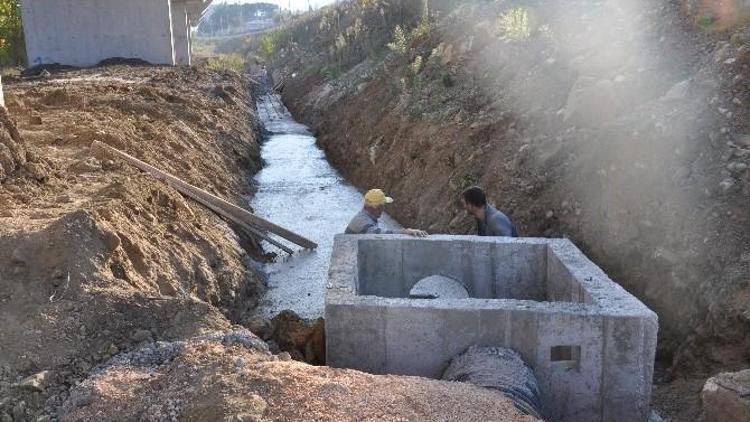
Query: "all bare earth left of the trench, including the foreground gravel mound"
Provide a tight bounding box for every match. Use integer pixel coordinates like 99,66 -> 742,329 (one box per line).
0,66 -> 536,422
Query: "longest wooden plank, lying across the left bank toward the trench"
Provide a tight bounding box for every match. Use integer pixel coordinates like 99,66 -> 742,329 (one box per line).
91,141 -> 318,249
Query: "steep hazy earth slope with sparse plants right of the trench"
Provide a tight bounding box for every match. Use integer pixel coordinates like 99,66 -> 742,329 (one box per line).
262,0 -> 750,416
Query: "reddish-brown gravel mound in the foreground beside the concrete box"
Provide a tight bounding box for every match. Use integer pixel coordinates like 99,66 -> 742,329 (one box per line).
60,331 -> 534,421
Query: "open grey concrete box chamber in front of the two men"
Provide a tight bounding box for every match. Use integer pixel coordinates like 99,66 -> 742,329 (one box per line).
325,235 -> 658,421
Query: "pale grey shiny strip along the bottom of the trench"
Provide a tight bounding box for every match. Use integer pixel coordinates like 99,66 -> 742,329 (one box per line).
251,94 -> 399,318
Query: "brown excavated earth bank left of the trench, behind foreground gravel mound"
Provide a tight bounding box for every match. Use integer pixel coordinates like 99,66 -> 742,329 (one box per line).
0,67 -> 263,421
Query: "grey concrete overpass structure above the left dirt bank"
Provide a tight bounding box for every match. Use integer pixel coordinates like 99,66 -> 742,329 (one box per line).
21,0 -> 212,66
